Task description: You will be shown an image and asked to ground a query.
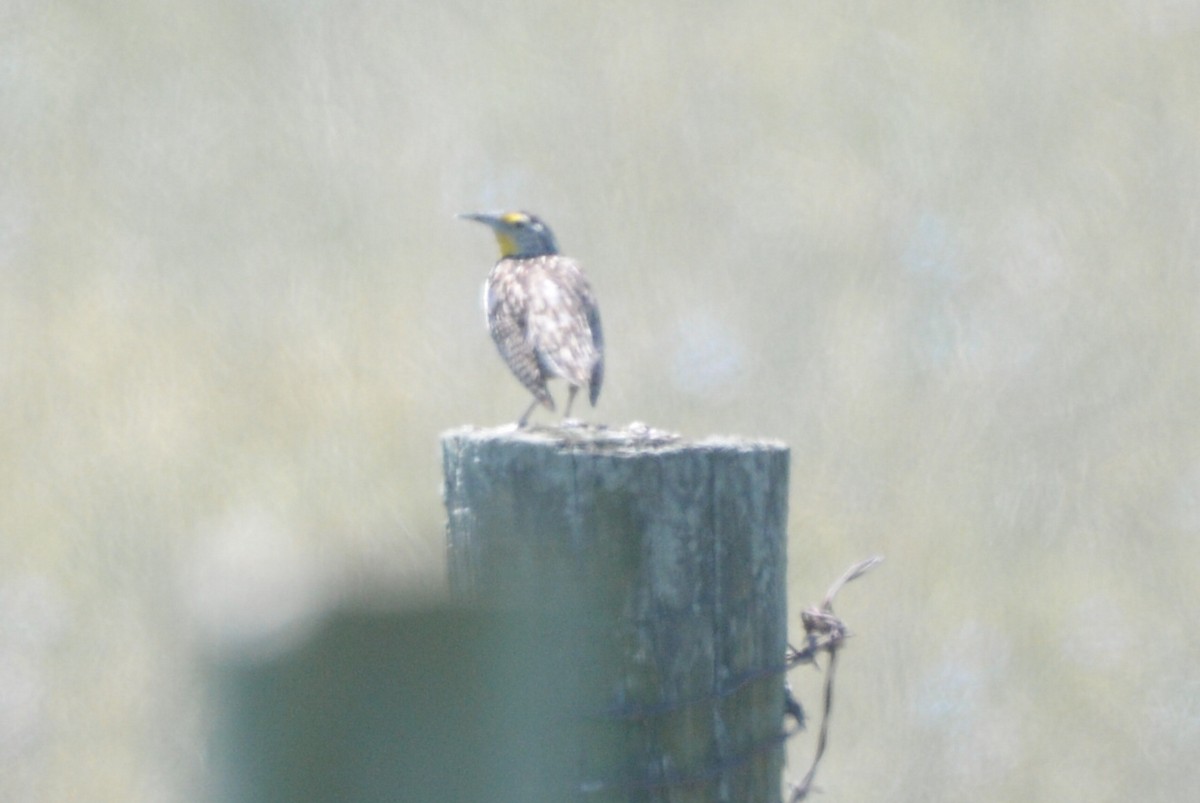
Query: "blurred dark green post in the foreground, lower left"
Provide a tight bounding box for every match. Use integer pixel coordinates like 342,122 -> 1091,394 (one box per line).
211,606 -> 578,803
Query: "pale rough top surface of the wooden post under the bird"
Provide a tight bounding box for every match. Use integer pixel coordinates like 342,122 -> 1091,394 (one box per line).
442,421 -> 787,455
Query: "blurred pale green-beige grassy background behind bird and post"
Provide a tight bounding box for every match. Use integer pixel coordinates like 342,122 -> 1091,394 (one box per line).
0,0 -> 1200,802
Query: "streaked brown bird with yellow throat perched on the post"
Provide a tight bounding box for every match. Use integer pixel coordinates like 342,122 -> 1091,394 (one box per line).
460,212 -> 604,426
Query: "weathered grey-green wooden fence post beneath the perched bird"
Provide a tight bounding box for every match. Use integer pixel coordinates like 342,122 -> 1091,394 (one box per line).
442,425 -> 788,803
